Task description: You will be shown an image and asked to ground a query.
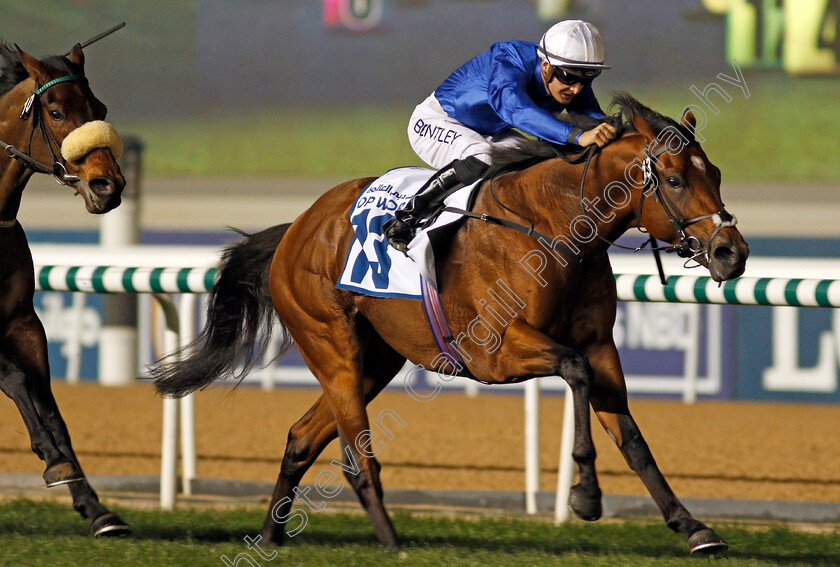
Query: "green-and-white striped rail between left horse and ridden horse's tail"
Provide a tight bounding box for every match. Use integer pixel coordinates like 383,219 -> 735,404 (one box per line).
35,265 -> 216,293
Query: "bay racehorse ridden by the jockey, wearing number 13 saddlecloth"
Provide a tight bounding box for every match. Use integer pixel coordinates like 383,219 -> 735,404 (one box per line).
153,94 -> 748,552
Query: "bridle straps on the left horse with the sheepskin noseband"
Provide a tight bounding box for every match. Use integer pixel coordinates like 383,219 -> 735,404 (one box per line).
0,75 -> 87,185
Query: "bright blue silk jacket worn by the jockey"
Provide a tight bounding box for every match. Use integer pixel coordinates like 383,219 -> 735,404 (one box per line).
435,41 -> 604,144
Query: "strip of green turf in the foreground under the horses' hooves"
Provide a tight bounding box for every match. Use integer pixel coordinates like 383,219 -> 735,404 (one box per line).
0,500 -> 840,567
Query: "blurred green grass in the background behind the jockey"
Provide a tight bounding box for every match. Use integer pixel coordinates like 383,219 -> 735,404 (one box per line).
118,73 -> 840,183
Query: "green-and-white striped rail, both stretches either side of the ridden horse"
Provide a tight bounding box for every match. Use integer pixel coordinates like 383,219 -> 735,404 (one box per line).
35,266 -> 840,307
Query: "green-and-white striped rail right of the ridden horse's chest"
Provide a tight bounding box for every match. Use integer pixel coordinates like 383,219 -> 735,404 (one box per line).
615,274 -> 840,307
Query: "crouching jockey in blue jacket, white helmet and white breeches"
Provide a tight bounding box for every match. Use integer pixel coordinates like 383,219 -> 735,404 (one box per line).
383,20 -> 615,252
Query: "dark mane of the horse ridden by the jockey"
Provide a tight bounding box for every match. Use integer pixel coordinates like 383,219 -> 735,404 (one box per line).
486,91 -> 694,178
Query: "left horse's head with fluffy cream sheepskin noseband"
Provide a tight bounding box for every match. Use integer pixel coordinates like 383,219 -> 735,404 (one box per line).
16,44 -> 125,214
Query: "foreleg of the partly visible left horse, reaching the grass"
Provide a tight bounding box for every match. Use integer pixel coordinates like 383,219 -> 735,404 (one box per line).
4,313 -> 131,536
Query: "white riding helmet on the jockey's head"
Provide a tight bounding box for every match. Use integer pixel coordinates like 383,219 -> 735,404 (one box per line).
537,20 -> 610,69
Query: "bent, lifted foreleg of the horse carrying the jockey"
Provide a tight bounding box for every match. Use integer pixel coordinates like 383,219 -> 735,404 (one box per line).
492,319 -> 603,521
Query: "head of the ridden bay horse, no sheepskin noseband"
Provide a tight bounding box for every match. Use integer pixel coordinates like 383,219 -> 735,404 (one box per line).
616,94 -> 749,281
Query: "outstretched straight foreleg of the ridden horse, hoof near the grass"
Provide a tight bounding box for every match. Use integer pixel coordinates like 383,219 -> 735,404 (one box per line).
587,343 -> 728,553
